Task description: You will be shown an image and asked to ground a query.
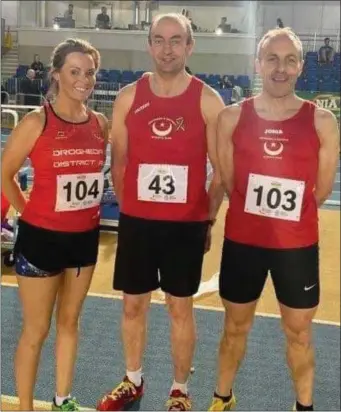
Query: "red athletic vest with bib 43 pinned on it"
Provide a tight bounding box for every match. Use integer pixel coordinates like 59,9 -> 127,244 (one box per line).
121,76 -> 208,221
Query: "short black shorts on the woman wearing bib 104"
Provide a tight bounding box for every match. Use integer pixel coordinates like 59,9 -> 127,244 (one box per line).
14,220 -> 99,277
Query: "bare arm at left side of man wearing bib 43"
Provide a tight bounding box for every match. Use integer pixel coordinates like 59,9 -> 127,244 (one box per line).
110,83 -> 136,207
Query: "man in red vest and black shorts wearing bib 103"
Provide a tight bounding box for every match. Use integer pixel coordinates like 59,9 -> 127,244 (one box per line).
206,28 -> 339,411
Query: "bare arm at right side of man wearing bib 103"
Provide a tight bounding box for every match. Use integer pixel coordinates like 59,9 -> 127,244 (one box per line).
315,108 -> 340,206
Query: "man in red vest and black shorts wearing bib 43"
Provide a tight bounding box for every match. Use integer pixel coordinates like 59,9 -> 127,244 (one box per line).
98,14 -> 224,411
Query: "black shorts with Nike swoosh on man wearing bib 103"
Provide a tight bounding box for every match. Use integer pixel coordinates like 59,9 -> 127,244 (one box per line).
219,239 -> 320,309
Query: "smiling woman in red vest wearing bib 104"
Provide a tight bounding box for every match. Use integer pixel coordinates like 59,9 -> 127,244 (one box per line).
1,39 -> 108,411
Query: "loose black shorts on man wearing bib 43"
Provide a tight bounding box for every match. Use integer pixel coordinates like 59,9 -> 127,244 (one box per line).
113,214 -> 208,297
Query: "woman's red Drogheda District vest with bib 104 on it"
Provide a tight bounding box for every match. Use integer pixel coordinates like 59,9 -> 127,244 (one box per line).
21,105 -> 106,232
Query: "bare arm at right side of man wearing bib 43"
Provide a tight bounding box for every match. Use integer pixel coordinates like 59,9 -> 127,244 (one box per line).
201,86 -> 225,224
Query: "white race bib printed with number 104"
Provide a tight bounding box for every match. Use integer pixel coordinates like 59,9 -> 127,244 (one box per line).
55,173 -> 104,212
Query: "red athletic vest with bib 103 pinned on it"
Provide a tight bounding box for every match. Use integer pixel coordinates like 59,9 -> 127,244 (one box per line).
225,98 -> 320,249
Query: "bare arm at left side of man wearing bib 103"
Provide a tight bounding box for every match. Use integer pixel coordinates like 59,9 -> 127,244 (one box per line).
217,104 -> 241,196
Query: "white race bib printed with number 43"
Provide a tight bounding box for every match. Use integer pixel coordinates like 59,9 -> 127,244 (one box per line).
137,164 -> 188,203
